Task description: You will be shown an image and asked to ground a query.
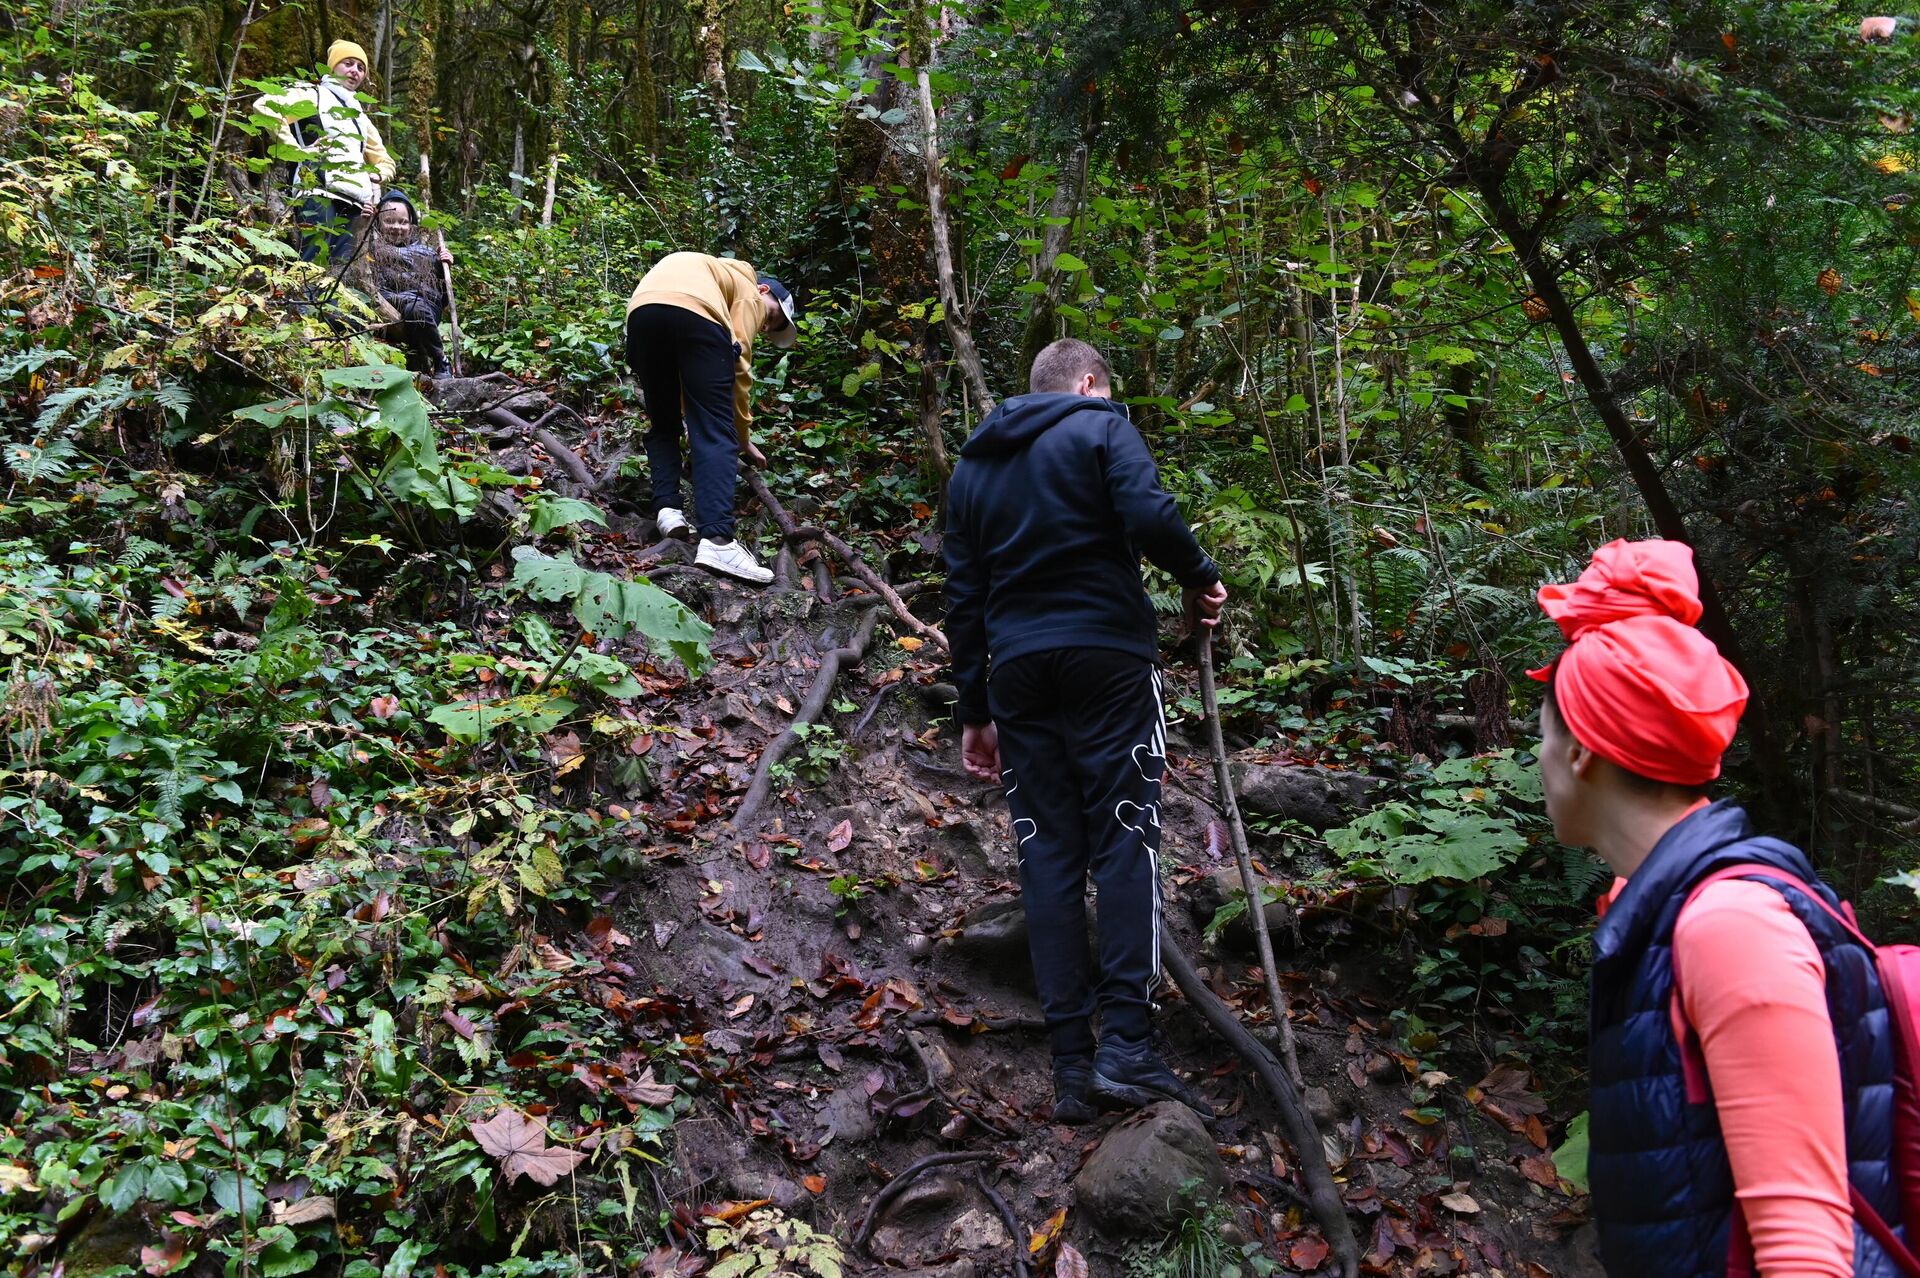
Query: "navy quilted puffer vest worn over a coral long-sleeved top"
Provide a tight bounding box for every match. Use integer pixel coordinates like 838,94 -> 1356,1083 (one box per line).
1588,802 -> 1901,1278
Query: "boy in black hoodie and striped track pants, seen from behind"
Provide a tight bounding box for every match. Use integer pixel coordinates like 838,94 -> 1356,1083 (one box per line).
945,338 -> 1227,1123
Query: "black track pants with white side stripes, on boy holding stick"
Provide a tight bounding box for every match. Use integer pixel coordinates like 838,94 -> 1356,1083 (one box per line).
987,649 -> 1167,1055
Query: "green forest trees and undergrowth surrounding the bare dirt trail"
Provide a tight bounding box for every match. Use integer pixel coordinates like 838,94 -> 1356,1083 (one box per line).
0,0 -> 1920,1274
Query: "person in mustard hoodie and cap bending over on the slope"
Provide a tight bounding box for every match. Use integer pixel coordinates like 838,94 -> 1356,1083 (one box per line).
626,253 -> 799,585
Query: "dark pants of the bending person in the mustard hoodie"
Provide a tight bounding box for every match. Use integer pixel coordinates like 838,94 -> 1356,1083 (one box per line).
626,303 -> 739,541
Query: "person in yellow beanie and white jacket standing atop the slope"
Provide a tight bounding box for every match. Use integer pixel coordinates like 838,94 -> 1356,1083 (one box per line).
259,40 -> 394,265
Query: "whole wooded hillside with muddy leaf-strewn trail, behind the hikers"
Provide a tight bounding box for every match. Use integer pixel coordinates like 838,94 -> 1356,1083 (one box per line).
11,0 -> 1920,1278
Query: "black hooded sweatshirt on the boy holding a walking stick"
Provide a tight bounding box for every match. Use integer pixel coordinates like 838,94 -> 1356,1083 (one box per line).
947,395 -> 1219,723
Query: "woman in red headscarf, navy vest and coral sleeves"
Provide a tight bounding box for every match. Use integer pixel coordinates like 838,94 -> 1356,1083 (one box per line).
1532,541 -> 1899,1278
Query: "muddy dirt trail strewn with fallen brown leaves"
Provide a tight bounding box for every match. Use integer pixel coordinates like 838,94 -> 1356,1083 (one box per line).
506,510 -> 1599,1278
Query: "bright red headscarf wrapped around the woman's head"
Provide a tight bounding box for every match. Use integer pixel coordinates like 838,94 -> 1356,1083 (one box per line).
1528,539 -> 1747,785
